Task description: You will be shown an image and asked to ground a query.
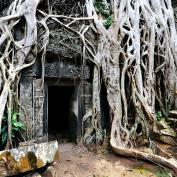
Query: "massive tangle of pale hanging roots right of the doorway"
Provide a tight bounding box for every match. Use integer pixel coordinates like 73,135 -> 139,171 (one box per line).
87,0 -> 177,173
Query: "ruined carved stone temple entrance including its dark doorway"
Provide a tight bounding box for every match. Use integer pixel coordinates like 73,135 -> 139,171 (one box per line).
19,40 -> 92,142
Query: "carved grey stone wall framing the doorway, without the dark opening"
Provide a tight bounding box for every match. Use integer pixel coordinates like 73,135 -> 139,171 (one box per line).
20,55 -> 92,142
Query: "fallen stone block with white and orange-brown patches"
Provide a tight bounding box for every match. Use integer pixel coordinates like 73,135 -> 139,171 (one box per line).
0,141 -> 59,177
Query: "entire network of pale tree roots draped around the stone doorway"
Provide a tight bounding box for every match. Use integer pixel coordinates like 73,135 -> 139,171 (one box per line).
0,0 -> 177,173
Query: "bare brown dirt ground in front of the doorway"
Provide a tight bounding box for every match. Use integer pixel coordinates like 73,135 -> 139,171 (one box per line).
43,143 -> 172,177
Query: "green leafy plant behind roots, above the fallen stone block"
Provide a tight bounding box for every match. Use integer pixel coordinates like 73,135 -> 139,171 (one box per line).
0,112 -> 24,149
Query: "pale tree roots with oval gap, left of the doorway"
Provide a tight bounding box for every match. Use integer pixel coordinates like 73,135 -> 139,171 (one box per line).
0,0 -> 40,138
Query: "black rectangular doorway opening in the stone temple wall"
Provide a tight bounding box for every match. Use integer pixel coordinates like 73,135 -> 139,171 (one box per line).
48,86 -> 77,143
